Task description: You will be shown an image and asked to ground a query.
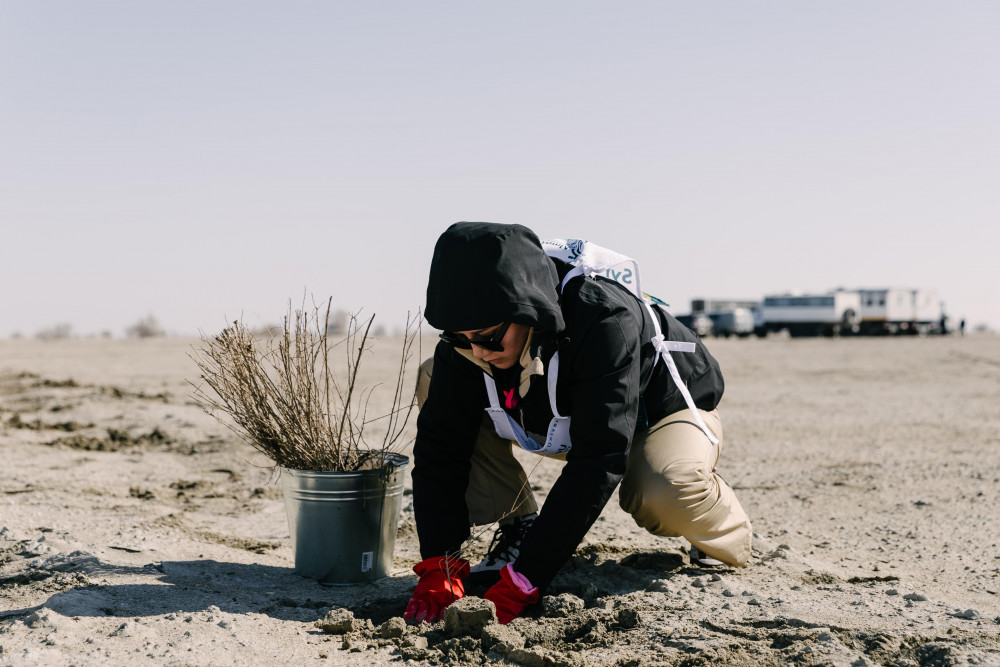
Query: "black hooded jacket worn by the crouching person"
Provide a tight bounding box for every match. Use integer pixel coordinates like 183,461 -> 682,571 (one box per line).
413,222 -> 723,588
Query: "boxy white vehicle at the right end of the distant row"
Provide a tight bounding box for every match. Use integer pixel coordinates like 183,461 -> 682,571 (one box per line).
858,287 -> 947,335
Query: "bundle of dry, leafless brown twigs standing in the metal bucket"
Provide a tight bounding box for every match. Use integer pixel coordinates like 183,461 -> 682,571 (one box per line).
192,301 -> 420,472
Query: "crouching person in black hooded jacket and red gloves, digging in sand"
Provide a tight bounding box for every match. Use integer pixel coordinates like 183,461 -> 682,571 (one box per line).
404,222 -> 751,623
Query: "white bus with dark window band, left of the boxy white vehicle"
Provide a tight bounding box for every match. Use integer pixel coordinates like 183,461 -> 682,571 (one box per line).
762,290 -> 861,337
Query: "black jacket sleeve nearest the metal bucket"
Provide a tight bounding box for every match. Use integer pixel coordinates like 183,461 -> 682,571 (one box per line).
412,343 -> 485,558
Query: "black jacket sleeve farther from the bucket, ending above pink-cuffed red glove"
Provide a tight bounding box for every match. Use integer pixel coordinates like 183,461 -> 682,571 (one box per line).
514,296 -> 640,588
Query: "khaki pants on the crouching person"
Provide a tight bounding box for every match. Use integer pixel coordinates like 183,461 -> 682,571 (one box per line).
417,359 -> 752,565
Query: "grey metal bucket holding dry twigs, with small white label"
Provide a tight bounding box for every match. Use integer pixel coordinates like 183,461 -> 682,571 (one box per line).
281,454 -> 410,585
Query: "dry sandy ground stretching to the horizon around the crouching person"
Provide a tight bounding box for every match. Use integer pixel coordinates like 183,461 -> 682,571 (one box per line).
0,335 -> 1000,665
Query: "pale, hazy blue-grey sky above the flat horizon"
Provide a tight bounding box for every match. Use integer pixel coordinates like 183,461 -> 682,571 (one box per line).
0,0 -> 1000,337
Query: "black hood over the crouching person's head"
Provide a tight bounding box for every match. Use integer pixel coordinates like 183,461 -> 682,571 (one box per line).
424,222 -> 565,332
